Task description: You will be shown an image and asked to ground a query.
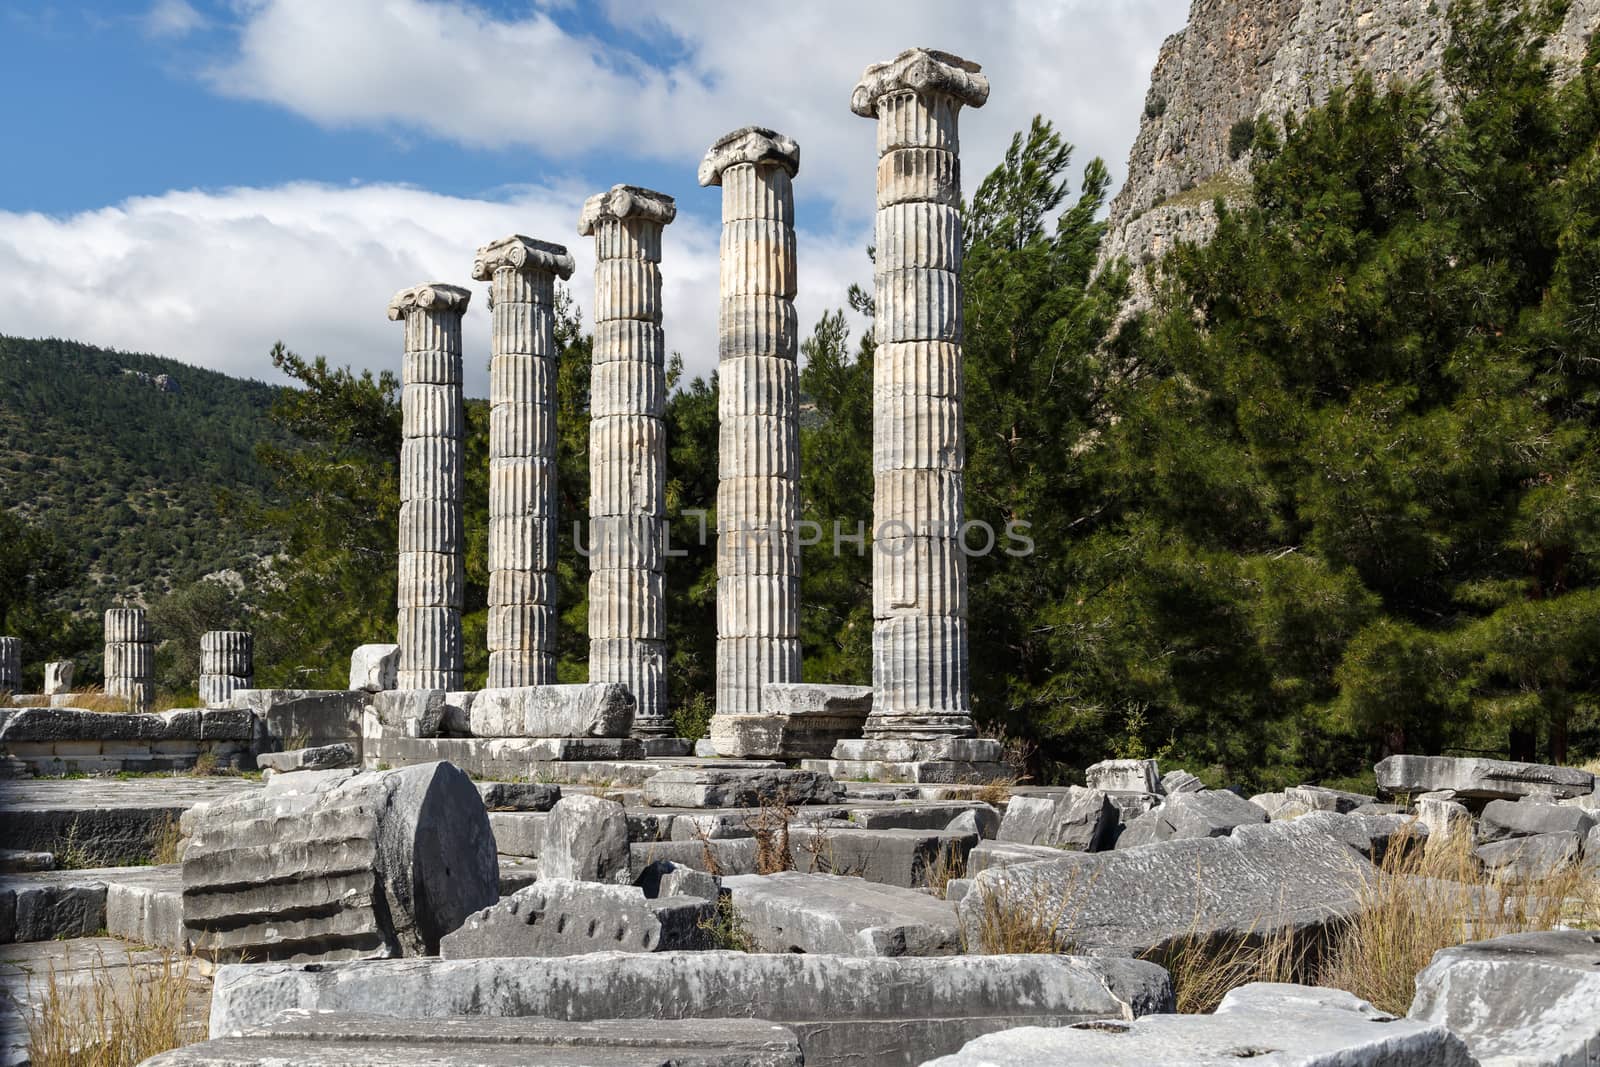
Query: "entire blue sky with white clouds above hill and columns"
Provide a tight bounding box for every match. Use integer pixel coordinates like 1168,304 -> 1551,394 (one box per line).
0,0 -> 1187,394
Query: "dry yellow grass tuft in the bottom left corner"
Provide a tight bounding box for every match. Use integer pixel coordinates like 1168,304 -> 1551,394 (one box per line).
27,952 -> 205,1067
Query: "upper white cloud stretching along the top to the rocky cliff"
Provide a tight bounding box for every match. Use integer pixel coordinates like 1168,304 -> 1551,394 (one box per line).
210,0 -> 1187,219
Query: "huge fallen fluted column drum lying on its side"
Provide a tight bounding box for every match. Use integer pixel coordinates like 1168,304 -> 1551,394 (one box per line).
182,763 -> 499,960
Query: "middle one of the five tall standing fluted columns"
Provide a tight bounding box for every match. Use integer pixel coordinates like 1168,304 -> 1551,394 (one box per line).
578,186 -> 677,739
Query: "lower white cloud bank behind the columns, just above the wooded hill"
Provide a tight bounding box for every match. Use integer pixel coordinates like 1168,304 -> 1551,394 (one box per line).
0,182 -> 867,395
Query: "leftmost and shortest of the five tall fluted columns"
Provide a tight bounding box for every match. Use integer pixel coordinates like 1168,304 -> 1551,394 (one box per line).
389,282 -> 472,689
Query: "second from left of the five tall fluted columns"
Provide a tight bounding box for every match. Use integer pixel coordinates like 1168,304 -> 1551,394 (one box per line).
472,235 -> 573,689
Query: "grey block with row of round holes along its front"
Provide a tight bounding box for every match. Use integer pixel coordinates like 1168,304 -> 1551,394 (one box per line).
438,878 -> 717,960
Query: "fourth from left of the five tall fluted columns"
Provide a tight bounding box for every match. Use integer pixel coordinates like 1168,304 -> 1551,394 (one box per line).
699,126 -> 800,726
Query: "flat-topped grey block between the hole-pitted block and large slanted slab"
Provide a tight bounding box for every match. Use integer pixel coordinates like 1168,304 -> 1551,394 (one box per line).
722,870 -> 962,957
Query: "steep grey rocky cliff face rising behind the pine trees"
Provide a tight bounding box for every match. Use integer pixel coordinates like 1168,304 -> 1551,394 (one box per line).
1101,0 -> 1600,302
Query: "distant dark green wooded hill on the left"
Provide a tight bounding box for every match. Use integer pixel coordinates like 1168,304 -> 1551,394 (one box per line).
0,336 -> 278,611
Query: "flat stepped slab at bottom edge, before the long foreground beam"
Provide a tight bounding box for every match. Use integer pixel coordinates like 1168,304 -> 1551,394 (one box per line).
144,1009 -> 803,1067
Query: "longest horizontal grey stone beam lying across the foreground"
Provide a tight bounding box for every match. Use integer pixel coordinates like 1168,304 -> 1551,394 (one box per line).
211,952 -> 1173,1067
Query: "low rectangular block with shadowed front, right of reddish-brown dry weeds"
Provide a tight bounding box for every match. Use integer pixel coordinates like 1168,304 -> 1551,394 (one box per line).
789,825 -> 978,889
